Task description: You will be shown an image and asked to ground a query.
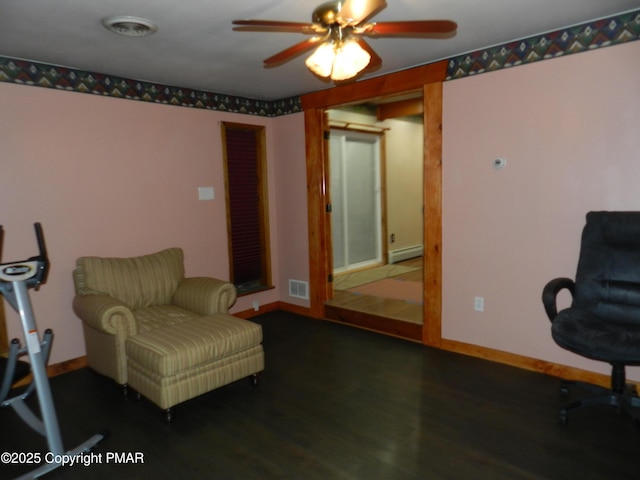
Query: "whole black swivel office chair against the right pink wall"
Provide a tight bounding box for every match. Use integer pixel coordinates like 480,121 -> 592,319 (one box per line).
542,212 -> 640,426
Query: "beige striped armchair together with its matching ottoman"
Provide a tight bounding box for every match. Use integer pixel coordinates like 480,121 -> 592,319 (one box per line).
73,248 -> 264,421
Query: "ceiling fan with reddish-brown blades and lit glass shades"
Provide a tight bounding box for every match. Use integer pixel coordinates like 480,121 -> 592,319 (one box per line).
233,0 -> 458,82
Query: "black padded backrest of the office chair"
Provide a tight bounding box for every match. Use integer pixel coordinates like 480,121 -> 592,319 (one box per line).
572,212 -> 640,324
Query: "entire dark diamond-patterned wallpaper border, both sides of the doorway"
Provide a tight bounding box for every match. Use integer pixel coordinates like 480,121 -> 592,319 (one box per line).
0,10 -> 640,117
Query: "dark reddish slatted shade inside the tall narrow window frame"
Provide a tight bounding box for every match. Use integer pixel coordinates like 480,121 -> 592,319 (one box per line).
225,128 -> 263,291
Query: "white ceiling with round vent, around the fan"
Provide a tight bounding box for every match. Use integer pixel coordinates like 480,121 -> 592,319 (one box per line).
0,0 -> 640,100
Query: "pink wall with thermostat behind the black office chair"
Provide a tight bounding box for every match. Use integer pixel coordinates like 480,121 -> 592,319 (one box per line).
442,42 -> 640,379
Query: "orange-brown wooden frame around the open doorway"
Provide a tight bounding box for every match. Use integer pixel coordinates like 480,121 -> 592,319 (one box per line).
301,60 -> 447,346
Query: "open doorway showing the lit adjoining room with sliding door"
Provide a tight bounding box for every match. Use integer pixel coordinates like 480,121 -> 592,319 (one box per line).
327,99 -> 424,326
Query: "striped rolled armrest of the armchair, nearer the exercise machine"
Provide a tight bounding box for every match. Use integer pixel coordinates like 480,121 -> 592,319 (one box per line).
73,294 -> 138,338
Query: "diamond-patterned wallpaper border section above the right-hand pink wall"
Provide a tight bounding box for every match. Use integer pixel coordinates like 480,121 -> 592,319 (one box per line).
446,10 -> 640,80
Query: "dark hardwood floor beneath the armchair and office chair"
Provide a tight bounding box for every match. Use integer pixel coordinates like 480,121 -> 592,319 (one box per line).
0,312 -> 640,480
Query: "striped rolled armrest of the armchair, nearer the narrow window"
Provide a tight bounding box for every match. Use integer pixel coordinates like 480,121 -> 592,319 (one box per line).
173,277 -> 237,315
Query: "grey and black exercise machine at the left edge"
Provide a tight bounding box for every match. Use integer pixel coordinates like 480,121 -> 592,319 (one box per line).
0,223 -> 105,478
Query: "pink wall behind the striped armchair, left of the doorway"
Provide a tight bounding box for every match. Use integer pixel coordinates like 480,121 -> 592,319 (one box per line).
0,82 -> 308,363
